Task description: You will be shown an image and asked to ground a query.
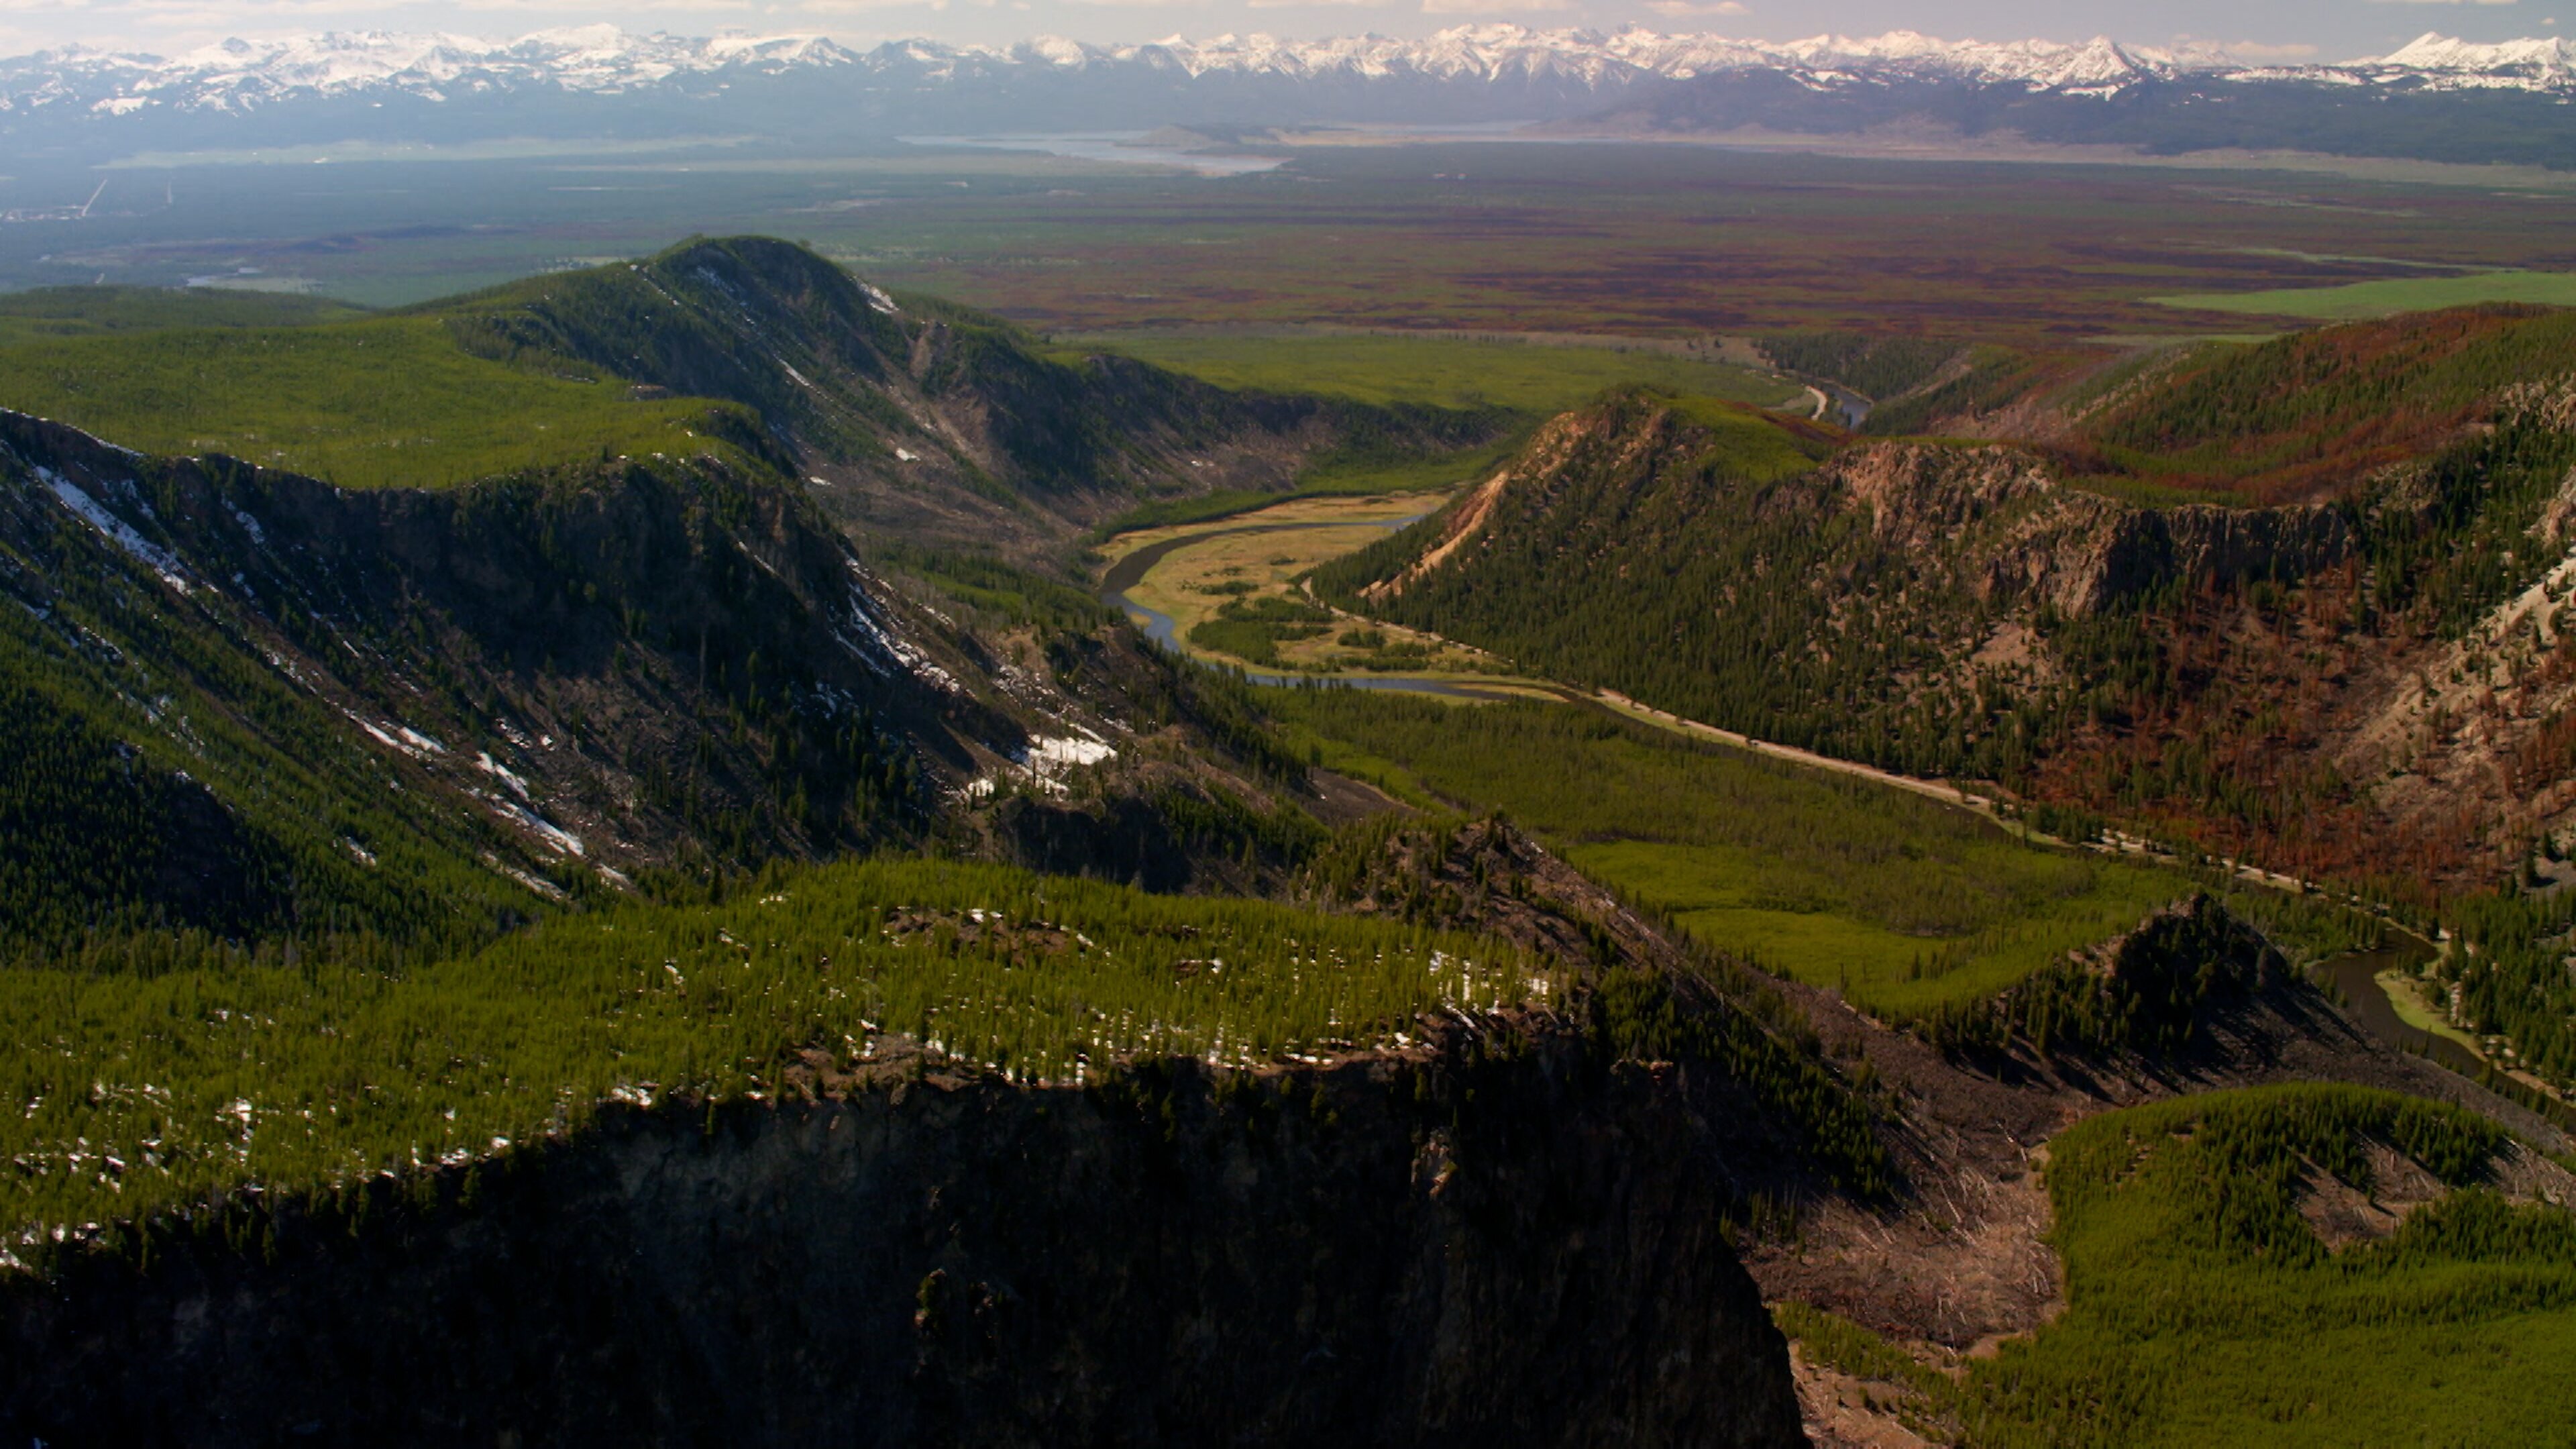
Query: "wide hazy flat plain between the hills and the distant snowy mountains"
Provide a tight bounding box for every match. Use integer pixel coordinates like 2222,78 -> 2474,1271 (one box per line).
15,142 -> 2576,340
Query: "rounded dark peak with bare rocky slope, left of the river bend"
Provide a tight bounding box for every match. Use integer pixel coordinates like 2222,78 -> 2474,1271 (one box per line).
433,237 -> 1507,547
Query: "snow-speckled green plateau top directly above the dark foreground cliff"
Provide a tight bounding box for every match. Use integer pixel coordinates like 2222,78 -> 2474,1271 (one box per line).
0,861 -> 1558,1253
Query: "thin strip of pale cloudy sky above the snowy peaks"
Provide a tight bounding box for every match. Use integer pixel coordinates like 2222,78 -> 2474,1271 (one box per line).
0,0 -> 2544,59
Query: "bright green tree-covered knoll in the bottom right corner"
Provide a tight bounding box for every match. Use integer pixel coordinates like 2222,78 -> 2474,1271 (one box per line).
1778,1085 -> 2576,1449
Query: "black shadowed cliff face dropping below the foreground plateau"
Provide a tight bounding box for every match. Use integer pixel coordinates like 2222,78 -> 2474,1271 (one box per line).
0,1024 -> 1803,1446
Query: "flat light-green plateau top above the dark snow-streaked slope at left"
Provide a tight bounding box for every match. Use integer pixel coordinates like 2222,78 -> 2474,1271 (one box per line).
0,317 -> 747,487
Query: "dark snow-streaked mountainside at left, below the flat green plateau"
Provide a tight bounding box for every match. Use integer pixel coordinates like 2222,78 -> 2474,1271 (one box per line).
0,389 -> 1311,957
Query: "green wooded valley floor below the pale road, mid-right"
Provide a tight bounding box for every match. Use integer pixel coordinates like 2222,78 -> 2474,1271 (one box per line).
1265,688 -> 2195,1018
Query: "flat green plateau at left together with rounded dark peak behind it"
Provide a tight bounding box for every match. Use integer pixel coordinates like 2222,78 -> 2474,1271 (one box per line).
0,237 -> 1512,559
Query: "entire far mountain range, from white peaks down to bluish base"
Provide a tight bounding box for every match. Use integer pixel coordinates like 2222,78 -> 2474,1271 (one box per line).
0,25 -> 2576,170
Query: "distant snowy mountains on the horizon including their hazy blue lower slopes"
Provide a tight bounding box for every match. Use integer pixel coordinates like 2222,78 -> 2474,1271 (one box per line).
15,23 -> 2576,163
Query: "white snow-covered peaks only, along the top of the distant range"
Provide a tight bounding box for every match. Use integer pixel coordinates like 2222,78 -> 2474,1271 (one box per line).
0,25 -> 2576,116
